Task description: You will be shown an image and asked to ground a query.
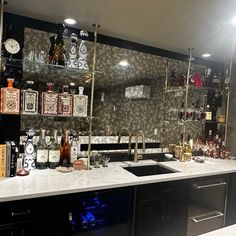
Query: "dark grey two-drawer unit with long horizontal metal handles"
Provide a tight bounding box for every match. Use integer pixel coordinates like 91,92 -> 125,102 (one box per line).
187,176 -> 228,236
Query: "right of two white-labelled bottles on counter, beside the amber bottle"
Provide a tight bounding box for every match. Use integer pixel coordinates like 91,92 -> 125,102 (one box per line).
48,130 -> 60,169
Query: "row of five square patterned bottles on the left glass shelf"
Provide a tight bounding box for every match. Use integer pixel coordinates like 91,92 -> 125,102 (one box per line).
0,78 -> 92,119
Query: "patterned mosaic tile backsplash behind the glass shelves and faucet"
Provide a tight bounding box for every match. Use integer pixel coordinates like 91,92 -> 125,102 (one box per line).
21,28 -> 205,144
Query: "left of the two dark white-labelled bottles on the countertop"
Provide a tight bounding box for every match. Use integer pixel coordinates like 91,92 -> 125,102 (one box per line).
36,129 -> 48,169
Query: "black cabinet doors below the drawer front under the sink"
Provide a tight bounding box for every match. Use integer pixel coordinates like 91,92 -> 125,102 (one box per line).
134,197 -> 187,236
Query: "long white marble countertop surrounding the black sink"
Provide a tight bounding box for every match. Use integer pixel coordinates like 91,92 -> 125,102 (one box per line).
0,158 -> 236,202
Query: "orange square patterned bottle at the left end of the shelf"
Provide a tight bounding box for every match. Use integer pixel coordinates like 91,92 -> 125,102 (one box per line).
1,78 -> 20,114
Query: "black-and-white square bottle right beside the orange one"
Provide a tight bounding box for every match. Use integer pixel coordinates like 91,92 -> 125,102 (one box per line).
21,81 -> 38,115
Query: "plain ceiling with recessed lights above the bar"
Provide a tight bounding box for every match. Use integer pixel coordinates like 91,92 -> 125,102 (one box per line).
5,0 -> 236,61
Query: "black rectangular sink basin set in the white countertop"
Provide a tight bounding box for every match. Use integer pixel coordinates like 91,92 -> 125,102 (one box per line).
123,165 -> 178,176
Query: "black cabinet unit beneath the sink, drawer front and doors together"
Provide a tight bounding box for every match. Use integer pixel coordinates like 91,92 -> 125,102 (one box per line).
134,181 -> 188,236
